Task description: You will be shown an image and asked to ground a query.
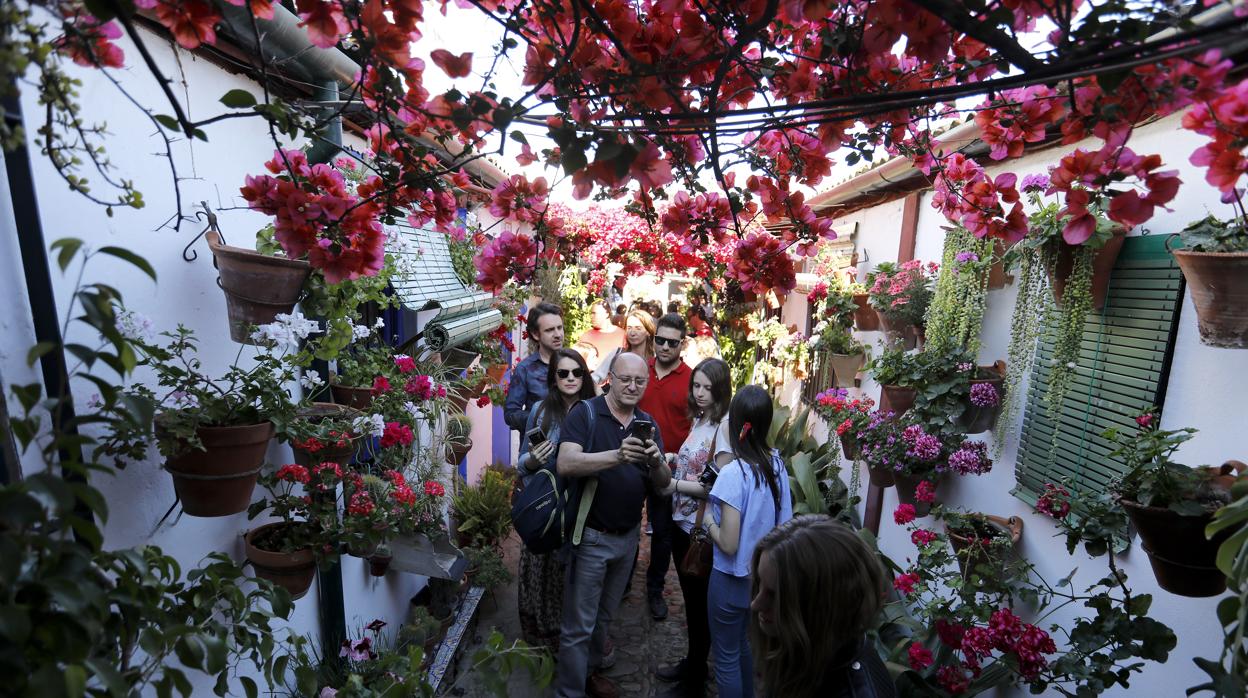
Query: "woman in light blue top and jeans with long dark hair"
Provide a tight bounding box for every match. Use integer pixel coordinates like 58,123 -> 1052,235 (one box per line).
706,386 -> 792,698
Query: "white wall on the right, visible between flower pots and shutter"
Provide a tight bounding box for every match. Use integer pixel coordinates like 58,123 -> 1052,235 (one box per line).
786,115 -> 1248,696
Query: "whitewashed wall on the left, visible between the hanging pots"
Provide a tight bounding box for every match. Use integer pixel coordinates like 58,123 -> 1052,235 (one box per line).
0,19 -> 490,694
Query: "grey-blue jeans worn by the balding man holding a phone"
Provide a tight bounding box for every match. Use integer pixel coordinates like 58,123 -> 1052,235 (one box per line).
555,526 -> 640,698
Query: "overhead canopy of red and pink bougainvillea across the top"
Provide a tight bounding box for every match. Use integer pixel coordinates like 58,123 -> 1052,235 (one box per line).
14,0 -> 1248,290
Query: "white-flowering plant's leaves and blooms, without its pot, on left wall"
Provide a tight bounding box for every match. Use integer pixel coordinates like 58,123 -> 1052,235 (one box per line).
102,324 -> 296,463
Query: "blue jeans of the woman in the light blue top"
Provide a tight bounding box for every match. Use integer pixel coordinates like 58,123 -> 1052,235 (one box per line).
706,569 -> 754,698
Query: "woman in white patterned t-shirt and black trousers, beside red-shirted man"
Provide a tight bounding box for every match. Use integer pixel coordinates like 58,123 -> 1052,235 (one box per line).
658,358 -> 733,697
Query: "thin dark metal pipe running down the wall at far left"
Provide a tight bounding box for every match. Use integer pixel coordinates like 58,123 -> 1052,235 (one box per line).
4,97 -> 92,514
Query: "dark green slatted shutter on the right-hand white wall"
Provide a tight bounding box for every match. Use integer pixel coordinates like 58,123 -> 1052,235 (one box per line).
1013,235 -> 1183,504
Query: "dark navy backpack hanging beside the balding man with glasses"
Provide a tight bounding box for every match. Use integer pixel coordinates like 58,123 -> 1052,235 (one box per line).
512,405 -> 598,554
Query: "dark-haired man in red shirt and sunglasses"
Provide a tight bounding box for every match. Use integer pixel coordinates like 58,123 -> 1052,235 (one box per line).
638,312 -> 693,621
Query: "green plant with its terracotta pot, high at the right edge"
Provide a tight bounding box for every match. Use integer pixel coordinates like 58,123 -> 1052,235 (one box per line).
1172,207 -> 1248,348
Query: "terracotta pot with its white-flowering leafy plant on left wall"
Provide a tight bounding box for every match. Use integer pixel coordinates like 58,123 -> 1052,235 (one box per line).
107,326 -> 295,517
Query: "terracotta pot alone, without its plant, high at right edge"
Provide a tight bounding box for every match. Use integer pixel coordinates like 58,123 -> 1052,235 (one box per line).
1172,250 -> 1248,348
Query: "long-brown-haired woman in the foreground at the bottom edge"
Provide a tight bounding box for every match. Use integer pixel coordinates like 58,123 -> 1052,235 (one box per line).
750,514 -> 896,698
